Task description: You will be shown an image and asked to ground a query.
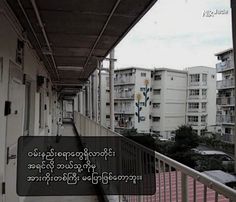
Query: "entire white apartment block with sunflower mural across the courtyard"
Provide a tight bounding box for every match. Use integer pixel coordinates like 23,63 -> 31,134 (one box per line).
98,66 -> 216,139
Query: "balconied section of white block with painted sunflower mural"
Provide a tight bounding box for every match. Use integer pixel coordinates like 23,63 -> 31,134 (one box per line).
114,67 -> 151,133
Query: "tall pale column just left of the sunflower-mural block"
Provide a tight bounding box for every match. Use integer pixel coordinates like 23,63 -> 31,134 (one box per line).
109,49 -> 115,131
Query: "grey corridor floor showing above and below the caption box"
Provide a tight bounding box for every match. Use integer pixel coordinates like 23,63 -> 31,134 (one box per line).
20,123 -> 98,202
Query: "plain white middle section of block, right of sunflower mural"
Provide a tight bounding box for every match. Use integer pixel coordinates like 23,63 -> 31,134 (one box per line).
150,68 -> 187,139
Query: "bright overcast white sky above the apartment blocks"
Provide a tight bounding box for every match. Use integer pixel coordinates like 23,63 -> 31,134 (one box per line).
115,0 -> 232,69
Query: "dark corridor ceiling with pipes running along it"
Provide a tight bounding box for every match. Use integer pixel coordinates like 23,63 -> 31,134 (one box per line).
7,0 -> 156,85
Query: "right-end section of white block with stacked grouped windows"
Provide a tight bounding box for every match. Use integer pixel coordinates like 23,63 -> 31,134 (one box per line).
186,66 -> 216,135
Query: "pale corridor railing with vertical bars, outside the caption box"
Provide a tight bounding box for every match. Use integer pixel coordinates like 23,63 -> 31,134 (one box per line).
75,112 -> 236,202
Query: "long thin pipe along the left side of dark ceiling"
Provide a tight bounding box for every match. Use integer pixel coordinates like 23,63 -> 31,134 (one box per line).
31,0 -> 59,78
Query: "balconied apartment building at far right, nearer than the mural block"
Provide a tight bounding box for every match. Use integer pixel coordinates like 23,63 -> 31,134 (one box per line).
215,49 -> 235,142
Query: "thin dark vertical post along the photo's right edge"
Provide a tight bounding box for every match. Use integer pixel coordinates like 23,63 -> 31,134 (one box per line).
231,0 -> 236,172
